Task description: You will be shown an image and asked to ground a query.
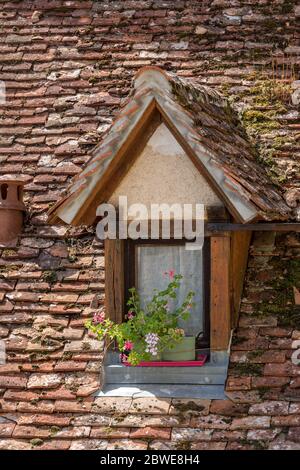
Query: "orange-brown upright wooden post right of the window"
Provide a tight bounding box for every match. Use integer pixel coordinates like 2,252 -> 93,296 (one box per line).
210,237 -> 231,351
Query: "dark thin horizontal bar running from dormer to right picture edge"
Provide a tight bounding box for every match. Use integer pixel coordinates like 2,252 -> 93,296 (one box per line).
206,222 -> 300,233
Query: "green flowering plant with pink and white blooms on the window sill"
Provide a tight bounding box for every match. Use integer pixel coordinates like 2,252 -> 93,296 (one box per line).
86,271 -> 195,366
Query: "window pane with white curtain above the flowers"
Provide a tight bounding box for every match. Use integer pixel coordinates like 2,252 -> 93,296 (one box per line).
136,245 -> 204,336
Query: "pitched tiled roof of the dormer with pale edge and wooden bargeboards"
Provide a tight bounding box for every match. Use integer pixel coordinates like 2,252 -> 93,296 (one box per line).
49,66 -> 291,225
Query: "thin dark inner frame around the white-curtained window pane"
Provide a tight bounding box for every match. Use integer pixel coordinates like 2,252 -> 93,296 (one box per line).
123,237 -> 210,349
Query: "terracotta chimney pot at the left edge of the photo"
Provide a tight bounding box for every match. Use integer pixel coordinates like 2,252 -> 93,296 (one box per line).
0,175 -> 26,246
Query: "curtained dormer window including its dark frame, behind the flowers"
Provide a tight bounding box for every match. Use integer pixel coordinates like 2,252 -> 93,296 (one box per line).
124,238 -> 210,349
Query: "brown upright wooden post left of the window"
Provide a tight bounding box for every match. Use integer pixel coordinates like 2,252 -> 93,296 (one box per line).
104,240 -> 124,323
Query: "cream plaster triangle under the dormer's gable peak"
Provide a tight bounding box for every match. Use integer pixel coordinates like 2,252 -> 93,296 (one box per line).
109,124 -> 222,210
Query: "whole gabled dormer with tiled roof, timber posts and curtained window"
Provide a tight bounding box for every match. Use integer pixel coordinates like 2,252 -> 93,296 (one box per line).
50,67 -> 288,398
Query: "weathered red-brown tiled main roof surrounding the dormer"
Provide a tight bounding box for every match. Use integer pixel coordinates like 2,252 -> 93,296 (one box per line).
0,0 -> 300,449
